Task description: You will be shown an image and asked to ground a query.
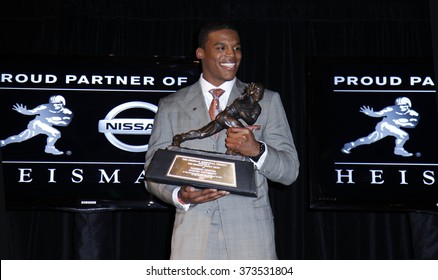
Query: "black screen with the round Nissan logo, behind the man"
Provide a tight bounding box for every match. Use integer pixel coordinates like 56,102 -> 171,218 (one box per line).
0,56 -> 200,211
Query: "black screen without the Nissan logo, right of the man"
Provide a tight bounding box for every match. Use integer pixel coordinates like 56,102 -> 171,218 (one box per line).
307,58 -> 438,212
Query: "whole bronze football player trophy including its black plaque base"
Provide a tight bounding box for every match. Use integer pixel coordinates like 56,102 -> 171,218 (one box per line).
145,83 -> 265,197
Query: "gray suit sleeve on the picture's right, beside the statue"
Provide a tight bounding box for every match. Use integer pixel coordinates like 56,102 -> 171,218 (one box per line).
258,92 -> 300,185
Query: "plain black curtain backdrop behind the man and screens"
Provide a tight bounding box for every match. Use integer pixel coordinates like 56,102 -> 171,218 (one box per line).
0,0 -> 438,259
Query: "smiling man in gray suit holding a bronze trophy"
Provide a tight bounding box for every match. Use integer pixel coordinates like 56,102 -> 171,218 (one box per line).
145,23 -> 299,260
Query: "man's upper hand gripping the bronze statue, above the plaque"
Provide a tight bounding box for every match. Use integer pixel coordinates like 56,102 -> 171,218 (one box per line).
225,127 -> 260,157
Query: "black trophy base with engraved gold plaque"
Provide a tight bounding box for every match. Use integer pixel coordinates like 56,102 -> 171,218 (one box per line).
145,146 -> 257,197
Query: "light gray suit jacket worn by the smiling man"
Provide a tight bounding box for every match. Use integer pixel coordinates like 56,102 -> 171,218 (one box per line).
145,77 -> 299,259
